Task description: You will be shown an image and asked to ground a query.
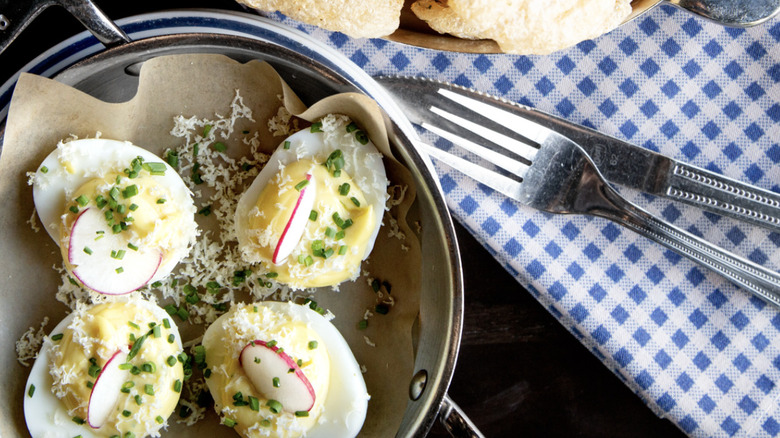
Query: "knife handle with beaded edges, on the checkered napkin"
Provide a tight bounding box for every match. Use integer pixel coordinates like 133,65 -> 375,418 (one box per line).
666,162 -> 780,232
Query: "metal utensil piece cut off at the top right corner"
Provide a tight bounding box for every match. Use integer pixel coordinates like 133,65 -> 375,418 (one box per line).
665,0 -> 780,27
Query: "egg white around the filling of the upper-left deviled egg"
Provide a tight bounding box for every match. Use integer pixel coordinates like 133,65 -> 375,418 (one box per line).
33,138 -> 196,283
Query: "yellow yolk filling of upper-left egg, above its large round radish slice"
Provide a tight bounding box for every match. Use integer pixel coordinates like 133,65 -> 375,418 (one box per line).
60,174 -> 184,270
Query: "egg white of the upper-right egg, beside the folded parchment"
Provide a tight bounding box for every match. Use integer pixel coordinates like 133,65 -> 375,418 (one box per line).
235,117 -> 388,260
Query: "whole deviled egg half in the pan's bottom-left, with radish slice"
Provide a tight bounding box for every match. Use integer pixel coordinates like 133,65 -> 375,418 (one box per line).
24,298 -> 184,438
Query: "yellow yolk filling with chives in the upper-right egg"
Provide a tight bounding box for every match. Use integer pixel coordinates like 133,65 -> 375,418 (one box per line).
249,160 -> 376,287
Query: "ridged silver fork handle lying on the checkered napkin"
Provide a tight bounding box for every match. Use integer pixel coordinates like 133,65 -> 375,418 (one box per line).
591,185 -> 780,306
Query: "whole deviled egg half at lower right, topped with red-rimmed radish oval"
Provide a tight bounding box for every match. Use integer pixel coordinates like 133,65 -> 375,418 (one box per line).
202,302 -> 369,438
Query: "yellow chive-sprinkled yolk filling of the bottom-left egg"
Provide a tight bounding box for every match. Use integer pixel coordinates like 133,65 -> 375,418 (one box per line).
50,302 -> 184,437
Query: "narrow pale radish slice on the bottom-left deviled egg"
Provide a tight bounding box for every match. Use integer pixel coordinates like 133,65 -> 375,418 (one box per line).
87,350 -> 128,429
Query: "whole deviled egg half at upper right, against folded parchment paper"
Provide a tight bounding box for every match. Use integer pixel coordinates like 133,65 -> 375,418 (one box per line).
235,115 -> 388,289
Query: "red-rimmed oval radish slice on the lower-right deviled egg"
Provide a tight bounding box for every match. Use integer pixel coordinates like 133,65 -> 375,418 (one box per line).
239,341 -> 315,412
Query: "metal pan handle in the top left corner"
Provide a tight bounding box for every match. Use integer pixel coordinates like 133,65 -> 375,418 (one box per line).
0,0 -> 130,53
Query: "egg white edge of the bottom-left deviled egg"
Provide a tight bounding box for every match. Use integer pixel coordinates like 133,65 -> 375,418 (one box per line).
24,300 -> 182,438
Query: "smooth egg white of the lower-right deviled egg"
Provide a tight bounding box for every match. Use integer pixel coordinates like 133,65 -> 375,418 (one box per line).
204,301 -> 370,438
